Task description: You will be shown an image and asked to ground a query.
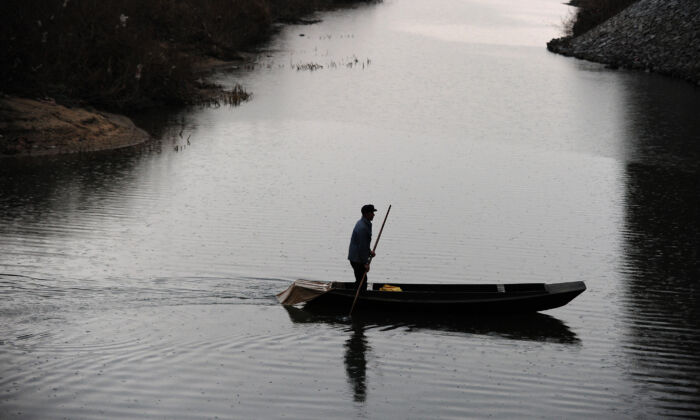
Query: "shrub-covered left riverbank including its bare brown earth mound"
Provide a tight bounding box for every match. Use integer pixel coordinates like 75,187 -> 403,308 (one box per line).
0,0 -> 378,157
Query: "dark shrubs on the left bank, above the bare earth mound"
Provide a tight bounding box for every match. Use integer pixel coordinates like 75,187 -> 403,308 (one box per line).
0,0 -> 374,110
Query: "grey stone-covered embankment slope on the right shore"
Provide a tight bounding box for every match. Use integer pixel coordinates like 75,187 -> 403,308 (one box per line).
547,0 -> 700,85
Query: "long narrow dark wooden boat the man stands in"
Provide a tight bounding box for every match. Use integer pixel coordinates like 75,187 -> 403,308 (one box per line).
277,280 -> 586,314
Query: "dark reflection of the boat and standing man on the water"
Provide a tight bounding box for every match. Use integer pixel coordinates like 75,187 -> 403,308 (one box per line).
283,305 -> 581,403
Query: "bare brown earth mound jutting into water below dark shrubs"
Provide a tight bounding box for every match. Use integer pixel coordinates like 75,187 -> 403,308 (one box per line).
0,96 -> 149,158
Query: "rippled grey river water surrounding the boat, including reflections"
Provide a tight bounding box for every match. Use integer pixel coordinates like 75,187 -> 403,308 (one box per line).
0,0 -> 700,419
